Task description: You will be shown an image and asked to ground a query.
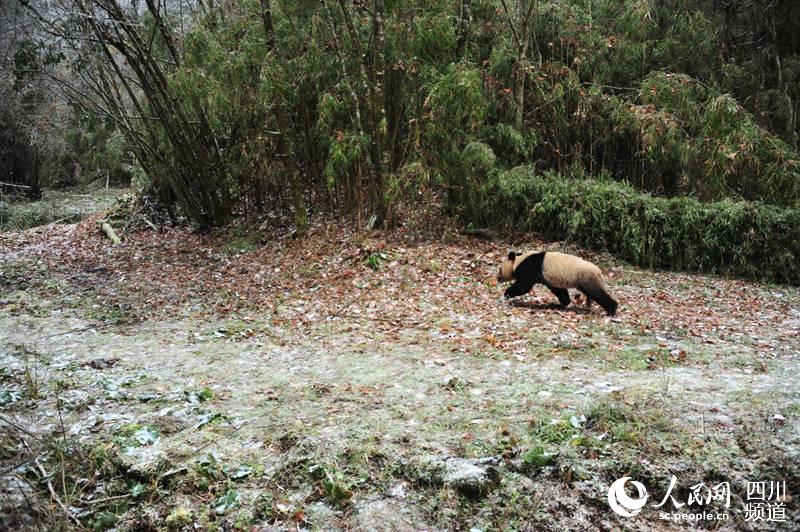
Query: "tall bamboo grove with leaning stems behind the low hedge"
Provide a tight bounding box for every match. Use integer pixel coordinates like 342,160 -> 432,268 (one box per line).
17,0 -> 800,280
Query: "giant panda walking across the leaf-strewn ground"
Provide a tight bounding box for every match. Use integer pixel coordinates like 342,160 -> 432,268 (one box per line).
497,251 -> 617,316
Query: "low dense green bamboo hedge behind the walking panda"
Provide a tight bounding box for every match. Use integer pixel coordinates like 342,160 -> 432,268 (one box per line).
472,167 -> 800,285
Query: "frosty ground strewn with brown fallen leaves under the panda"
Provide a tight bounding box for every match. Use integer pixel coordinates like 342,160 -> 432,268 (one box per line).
0,198 -> 800,530
